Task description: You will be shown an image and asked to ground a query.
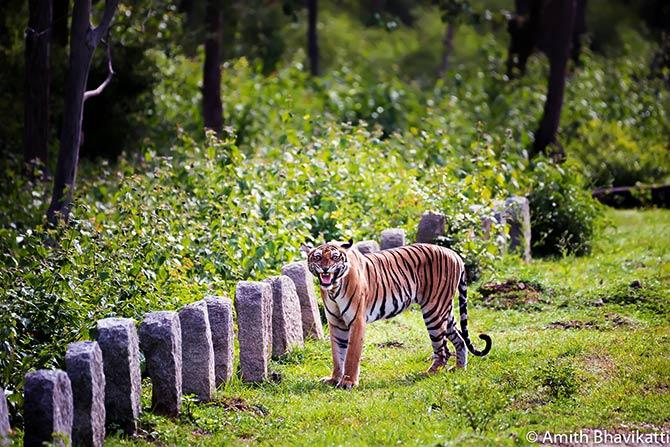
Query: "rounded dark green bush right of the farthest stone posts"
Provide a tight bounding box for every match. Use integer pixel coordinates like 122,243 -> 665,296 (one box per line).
529,161 -> 603,255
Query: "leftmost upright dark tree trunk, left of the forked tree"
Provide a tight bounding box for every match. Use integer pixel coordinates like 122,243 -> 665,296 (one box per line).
23,0 -> 52,172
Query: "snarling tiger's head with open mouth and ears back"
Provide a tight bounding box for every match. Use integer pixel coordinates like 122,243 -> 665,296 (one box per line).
301,240 -> 354,290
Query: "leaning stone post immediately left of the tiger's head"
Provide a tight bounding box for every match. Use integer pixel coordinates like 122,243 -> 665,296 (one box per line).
281,261 -> 323,339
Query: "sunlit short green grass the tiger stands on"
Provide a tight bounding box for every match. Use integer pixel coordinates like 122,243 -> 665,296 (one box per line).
100,210 -> 670,446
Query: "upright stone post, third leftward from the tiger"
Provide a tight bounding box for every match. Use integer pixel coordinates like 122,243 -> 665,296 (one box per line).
235,281 -> 272,382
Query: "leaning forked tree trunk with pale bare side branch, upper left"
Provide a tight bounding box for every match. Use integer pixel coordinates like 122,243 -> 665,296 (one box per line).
47,0 -> 119,224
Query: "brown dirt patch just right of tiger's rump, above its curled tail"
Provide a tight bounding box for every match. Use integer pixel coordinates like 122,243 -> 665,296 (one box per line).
479,279 -> 545,309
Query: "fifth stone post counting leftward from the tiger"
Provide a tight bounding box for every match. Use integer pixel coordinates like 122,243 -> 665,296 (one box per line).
179,301 -> 215,401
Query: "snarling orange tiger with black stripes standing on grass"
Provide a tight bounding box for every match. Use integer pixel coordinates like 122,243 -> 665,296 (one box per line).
301,240 -> 492,389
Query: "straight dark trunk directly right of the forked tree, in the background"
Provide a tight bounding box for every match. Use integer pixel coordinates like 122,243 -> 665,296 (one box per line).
202,0 -> 223,134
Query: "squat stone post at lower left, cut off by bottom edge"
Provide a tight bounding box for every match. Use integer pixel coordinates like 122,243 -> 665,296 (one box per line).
23,369 -> 72,447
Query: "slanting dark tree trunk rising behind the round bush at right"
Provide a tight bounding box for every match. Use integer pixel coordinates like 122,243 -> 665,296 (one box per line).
531,0 -> 575,161
